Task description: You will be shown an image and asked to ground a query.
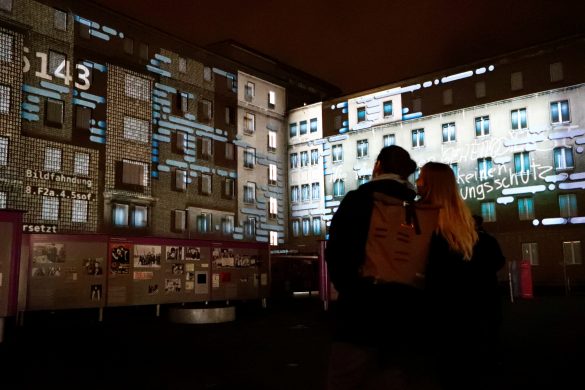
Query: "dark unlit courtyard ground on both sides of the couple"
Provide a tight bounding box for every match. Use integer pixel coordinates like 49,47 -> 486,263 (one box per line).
0,296 -> 585,390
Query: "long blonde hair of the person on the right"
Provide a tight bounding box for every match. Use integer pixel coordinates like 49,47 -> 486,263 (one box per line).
418,162 -> 478,260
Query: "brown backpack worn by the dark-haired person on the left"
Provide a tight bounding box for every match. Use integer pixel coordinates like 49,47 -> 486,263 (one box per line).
361,192 -> 439,287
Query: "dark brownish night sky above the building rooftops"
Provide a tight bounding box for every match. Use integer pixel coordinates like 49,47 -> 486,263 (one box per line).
93,0 -> 585,94
